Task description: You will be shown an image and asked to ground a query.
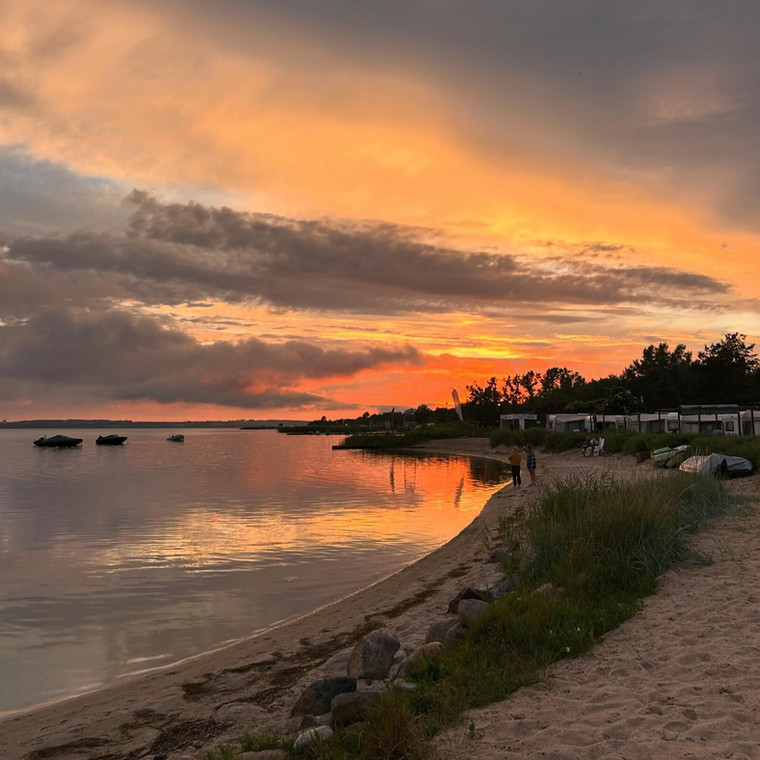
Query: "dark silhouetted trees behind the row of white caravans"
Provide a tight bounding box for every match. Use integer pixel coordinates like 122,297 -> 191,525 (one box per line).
462,333 -> 760,427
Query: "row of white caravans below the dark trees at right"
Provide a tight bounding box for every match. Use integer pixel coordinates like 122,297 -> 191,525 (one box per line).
500,404 -> 760,435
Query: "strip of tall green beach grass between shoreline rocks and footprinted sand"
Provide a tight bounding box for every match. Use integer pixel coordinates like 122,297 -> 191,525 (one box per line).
209,472 -> 732,760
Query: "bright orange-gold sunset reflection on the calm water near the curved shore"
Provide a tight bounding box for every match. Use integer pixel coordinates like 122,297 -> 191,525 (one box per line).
91,452 -> 504,573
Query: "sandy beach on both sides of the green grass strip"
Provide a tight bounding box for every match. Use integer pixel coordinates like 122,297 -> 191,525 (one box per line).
0,439 -> 760,760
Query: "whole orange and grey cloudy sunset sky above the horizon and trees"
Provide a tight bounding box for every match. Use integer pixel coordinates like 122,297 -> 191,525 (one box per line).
0,0 -> 760,420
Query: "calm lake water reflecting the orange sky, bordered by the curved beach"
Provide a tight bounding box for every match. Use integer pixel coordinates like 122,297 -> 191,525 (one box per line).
0,429 -> 503,715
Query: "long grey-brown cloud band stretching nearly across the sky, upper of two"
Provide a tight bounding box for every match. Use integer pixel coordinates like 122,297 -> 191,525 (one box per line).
0,191 -> 728,316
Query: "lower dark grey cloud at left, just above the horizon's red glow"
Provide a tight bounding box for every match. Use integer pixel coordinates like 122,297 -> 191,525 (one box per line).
0,307 -> 422,409
